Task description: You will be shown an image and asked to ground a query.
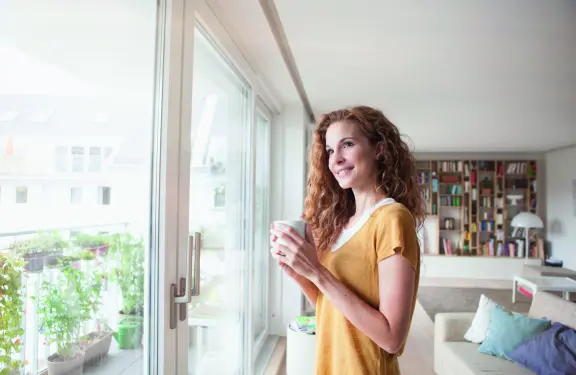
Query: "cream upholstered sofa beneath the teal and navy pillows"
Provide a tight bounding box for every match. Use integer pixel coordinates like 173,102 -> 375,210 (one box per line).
434,292 -> 576,375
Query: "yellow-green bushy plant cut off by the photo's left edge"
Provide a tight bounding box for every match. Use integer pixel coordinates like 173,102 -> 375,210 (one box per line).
0,254 -> 24,375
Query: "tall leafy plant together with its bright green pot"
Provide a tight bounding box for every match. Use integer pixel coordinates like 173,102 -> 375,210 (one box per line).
111,233 -> 144,349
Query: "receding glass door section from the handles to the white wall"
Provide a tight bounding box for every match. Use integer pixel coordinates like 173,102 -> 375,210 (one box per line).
180,27 -> 271,375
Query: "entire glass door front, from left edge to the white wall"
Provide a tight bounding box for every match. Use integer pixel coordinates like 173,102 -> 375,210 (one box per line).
0,0 -> 271,375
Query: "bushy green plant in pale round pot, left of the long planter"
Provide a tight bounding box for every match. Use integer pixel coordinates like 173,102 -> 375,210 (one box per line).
37,263 -> 90,375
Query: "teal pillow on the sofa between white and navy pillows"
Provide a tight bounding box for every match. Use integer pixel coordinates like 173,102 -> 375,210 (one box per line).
478,306 -> 550,359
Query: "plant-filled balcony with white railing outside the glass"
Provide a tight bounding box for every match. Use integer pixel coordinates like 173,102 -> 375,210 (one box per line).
0,223 -> 145,375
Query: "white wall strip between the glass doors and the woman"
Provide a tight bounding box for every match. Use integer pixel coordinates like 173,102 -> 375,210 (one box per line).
270,103 -> 308,335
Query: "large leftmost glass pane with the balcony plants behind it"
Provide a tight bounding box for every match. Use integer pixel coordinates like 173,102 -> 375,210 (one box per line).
0,0 -> 157,375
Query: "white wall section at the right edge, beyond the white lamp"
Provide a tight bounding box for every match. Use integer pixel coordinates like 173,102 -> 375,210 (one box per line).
546,146 -> 576,270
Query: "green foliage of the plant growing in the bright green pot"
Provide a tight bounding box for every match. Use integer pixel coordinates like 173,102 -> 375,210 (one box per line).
110,233 -> 144,315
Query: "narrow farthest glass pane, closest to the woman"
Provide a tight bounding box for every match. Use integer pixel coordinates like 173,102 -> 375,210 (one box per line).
252,113 -> 270,342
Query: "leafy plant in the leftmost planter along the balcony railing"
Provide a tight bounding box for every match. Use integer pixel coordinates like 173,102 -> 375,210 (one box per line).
9,232 -> 68,272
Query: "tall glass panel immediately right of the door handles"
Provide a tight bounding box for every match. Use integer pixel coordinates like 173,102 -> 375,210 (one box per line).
188,30 -> 250,375
